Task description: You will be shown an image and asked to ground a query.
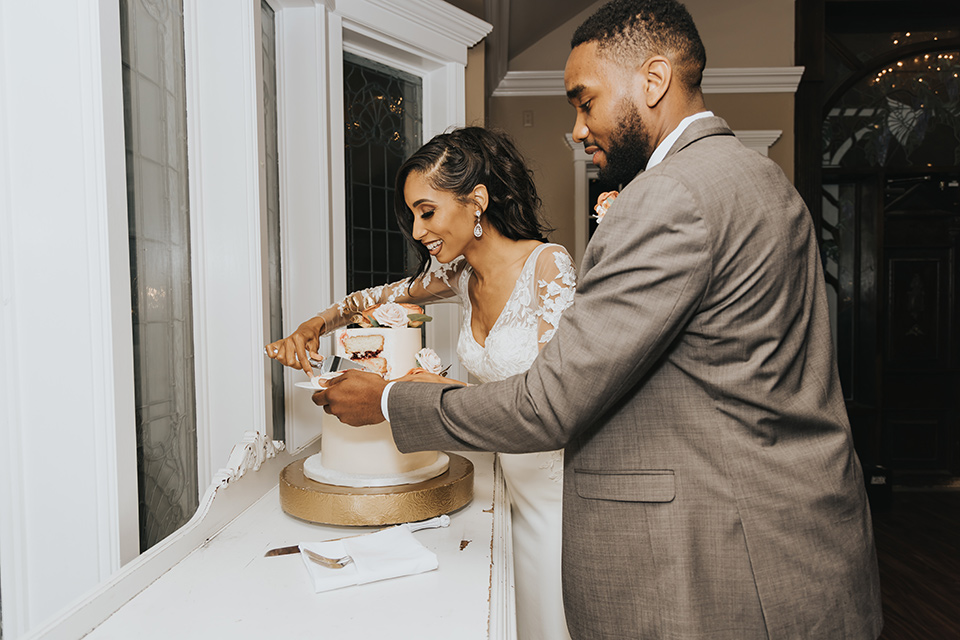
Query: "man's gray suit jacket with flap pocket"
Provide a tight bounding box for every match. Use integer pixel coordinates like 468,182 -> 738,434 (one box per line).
389,117 -> 881,640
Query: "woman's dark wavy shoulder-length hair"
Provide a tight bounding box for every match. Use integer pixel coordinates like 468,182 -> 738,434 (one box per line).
394,127 -> 552,278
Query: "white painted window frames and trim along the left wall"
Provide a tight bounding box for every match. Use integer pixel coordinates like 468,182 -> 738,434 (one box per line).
0,0 -> 489,637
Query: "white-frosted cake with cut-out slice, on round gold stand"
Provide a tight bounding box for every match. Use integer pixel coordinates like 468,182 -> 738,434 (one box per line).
303,328 -> 449,487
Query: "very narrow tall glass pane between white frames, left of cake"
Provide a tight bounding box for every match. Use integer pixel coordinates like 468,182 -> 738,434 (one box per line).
260,0 -> 285,440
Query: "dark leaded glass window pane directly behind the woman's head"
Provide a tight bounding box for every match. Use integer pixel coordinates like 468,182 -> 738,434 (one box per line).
343,53 -> 422,291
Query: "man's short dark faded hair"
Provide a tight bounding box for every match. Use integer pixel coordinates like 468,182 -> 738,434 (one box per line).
570,0 -> 707,90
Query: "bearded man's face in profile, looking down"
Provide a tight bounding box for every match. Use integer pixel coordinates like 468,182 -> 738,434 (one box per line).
564,42 -> 653,188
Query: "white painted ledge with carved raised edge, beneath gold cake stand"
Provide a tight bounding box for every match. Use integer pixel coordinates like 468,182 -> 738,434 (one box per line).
21,444 -> 516,640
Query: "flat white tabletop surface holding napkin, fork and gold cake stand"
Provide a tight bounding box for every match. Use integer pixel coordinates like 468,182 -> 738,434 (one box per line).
38,453 -> 513,640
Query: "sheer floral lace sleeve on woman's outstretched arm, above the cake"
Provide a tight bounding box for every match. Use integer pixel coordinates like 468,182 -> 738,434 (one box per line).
317,256 -> 466,333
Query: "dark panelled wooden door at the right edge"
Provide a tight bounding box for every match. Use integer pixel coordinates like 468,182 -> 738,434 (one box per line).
880,174 -> 960,474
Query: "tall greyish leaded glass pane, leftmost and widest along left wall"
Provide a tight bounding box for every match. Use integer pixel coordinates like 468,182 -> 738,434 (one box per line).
120,0 -> 199,551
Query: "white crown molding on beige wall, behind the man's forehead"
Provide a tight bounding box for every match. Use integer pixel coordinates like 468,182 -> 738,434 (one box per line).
493,67 -> 803,98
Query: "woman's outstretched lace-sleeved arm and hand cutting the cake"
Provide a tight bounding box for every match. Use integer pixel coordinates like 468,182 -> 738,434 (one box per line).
264,258 -> 466,375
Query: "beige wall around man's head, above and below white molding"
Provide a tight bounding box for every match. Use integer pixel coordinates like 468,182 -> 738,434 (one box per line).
487,0 -> 794,253
